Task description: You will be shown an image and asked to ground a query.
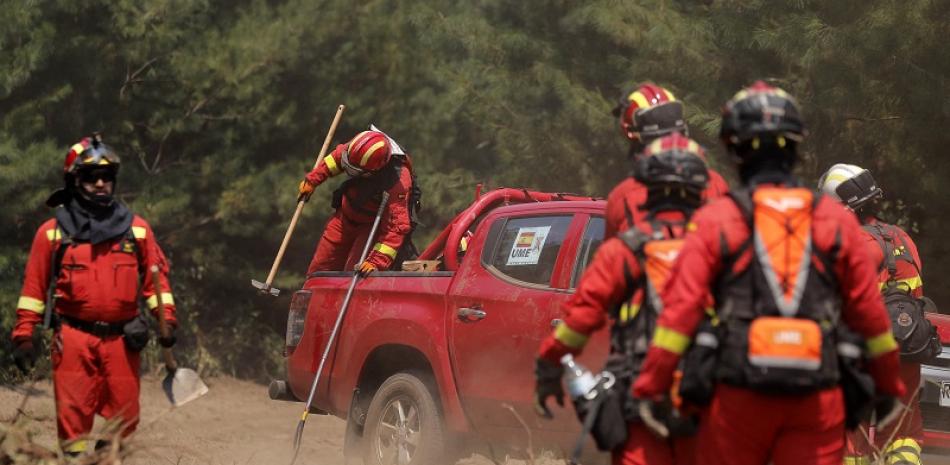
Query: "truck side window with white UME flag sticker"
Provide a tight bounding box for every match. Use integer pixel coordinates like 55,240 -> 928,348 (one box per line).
490,215 -> 572,286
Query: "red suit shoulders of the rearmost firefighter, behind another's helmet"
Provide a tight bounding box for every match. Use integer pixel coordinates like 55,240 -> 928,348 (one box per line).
604,169 -> 729,238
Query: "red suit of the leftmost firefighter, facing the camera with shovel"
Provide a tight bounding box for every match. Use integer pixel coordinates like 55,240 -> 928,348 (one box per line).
12,216 -> 177,452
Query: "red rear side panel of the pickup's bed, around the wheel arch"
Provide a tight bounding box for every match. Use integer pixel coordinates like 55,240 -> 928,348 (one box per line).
287,272 -> 454,416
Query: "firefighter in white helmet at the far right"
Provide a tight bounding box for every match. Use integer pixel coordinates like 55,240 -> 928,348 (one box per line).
818,163 -> 924,465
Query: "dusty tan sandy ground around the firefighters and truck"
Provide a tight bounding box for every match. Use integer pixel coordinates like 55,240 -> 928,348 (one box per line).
0,376 -> 950,465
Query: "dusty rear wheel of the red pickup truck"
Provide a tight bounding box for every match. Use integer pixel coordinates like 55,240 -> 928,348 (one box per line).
362,373 -> 445,465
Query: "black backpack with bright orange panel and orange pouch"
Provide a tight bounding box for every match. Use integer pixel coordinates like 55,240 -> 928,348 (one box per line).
713,187 -> 841,394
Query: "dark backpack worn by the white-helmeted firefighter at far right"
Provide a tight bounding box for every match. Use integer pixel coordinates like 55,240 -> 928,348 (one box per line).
863,224 -> 943,363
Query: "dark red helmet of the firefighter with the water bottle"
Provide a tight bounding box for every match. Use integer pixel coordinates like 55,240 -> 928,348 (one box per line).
634,133 -> 709,211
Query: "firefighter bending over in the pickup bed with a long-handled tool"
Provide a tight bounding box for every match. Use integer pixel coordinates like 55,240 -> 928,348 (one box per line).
300,128 -> 414,275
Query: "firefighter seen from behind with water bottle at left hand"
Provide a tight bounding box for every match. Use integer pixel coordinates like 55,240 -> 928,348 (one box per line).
535,133 -> 709,465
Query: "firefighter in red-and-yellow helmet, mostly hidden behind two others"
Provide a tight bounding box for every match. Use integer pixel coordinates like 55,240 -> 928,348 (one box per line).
604,83 -> 729,238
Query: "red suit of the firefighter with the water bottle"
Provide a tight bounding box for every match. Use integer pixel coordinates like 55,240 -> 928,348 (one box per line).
539,211 -> 693,465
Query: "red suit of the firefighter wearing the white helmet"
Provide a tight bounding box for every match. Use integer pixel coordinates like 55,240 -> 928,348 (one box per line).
847,216 -> 924,463
